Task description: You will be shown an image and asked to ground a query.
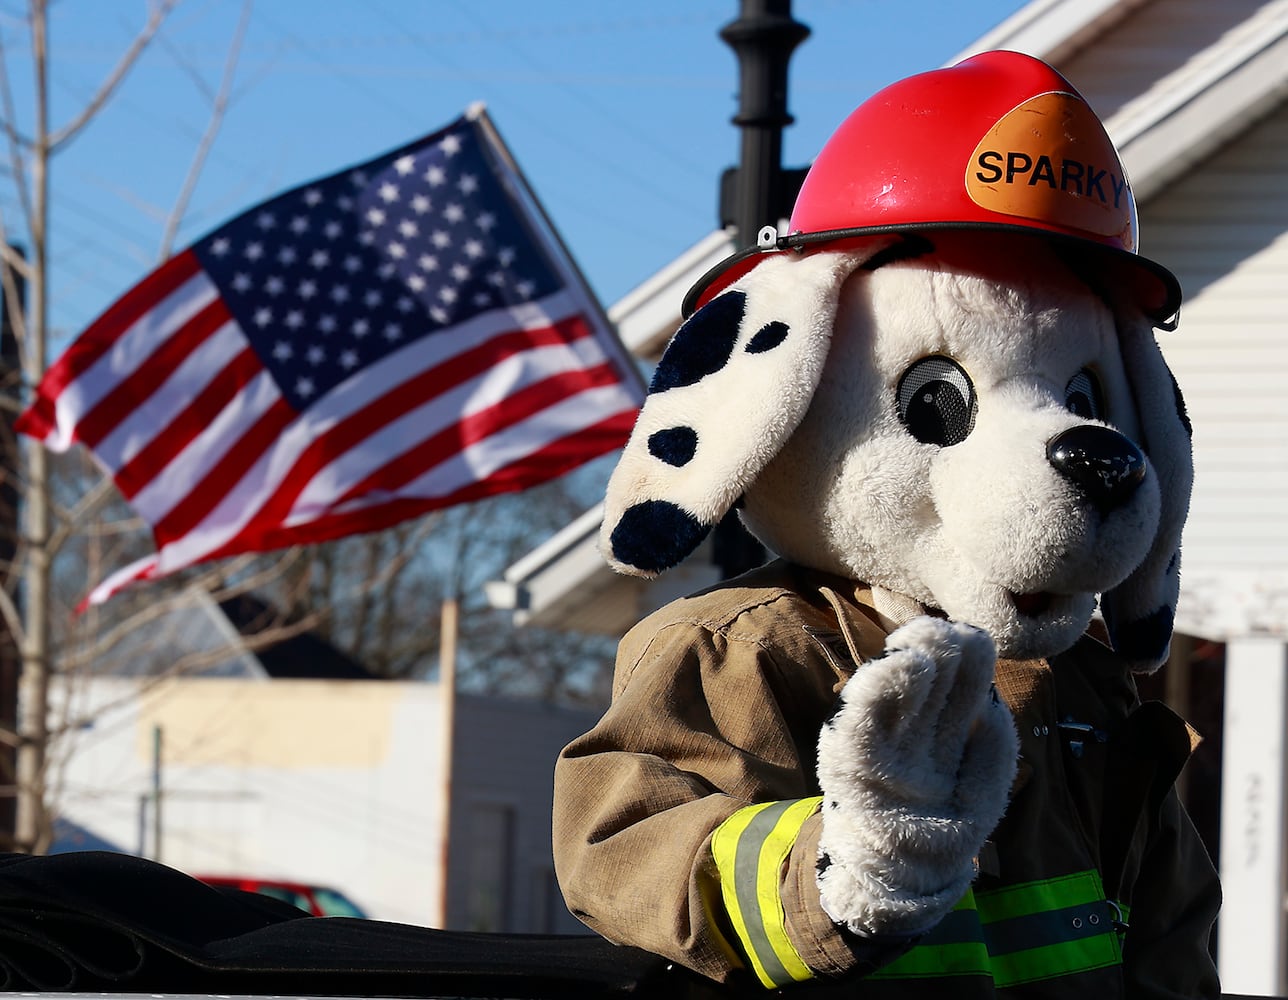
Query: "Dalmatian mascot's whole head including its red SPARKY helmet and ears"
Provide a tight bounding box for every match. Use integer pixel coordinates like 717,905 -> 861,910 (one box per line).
601,53 -> 1191,670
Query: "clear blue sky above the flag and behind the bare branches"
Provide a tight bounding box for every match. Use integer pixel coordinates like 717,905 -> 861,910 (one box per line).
0,0 -> 1024,338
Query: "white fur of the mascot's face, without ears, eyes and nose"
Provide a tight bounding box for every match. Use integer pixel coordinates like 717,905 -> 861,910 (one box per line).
742,240 -> 1159,656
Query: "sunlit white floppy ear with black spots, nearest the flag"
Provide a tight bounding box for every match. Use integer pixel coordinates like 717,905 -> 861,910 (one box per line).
600,246 -> 880,577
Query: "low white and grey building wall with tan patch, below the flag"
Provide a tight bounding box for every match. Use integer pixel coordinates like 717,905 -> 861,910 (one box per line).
46,678 -> 594,932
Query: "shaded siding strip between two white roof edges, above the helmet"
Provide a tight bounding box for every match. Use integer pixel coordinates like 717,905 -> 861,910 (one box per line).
1059,0 -> 1283,120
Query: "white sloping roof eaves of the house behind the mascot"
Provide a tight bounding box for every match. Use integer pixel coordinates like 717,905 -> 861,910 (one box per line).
489,0 -> 1288,631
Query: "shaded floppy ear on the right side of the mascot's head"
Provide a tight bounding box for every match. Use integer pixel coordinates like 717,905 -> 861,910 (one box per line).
1100,311 -> 1194,674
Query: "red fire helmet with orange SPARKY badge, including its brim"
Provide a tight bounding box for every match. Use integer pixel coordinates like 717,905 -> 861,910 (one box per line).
684,52 -> 1181,325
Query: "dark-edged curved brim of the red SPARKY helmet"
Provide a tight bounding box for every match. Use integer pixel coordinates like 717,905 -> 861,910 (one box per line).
681,222 -> 1181,330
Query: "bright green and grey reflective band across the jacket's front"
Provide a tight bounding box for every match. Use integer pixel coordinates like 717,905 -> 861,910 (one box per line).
873,871 -> 1122,987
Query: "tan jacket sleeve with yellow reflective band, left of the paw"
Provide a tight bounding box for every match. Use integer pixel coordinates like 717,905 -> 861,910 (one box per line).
554,615 -> 905,986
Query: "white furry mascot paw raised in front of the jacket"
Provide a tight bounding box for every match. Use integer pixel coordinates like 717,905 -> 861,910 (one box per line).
818,617 -> 1018,936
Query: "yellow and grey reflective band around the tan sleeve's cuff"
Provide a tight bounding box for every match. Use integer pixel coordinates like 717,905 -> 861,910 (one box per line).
711,796 -> 823,987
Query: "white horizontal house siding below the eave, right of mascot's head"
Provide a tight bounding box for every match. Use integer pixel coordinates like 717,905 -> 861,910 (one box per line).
1141,99 -> 1288,638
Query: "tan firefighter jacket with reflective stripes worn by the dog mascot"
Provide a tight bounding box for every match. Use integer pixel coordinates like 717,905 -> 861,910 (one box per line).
554,562 -> 1220,1000
